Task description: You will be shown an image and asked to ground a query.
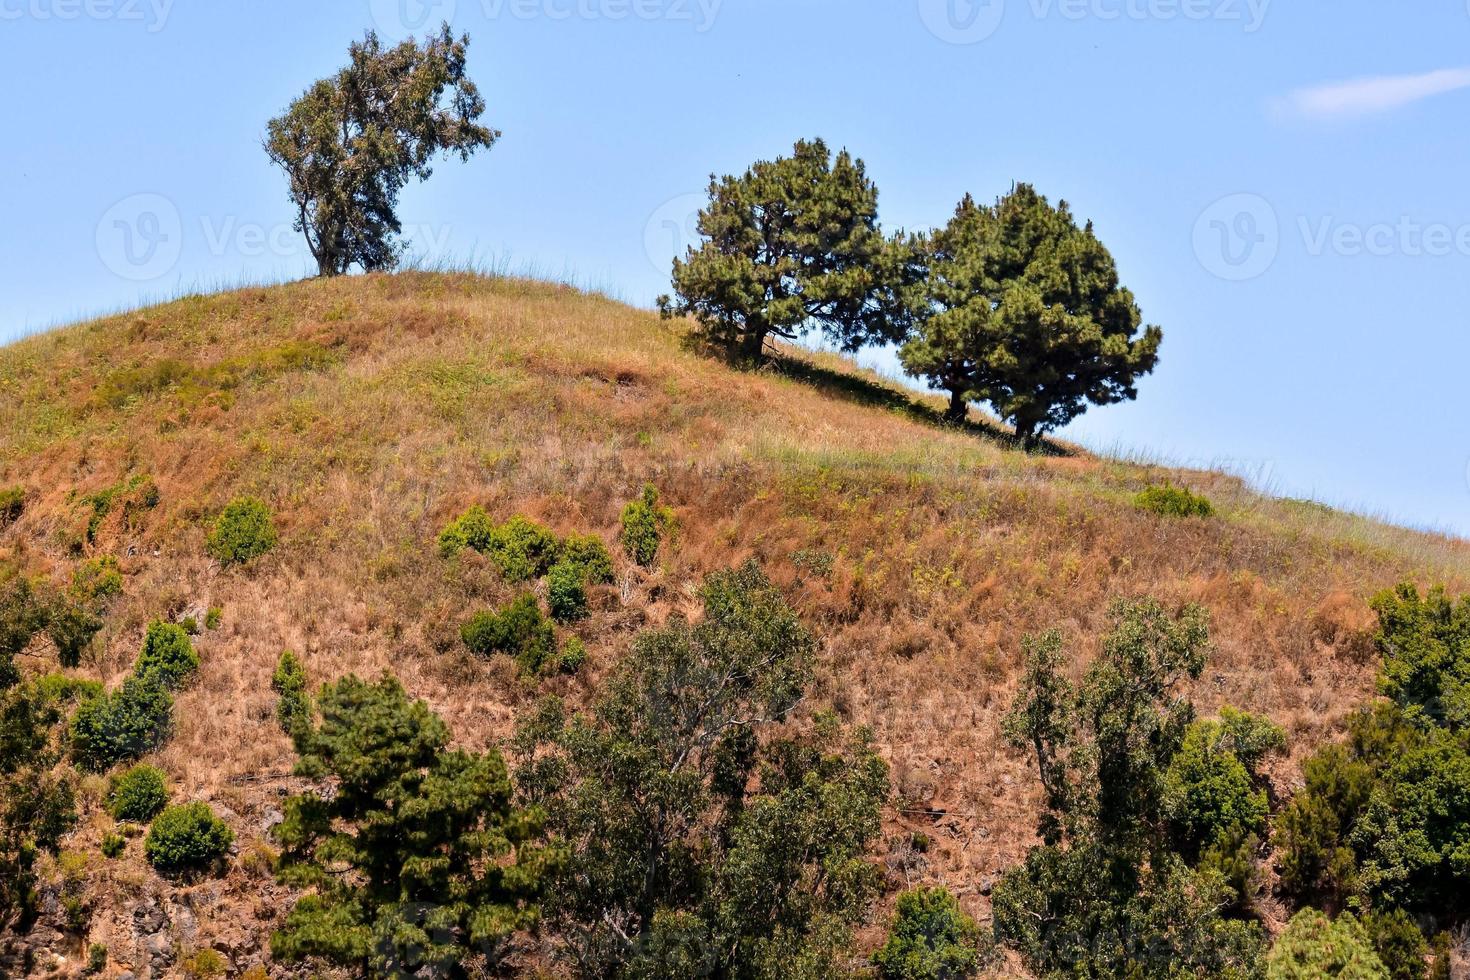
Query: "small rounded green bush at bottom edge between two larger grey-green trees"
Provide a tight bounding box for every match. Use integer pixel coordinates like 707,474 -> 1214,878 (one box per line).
873,887 -> 980,980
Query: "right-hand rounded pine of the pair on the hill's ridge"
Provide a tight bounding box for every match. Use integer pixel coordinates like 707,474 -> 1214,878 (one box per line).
900,184 -> 1163,448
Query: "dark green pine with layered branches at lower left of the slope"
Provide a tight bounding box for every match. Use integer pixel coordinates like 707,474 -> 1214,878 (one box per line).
270,677 -> 559,976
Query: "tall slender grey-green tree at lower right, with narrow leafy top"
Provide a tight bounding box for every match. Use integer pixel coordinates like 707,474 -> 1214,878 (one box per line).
992,599 -> 1270,979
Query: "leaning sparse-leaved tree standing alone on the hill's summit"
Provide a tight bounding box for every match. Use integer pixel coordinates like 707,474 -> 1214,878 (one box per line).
265,24 -> 500,276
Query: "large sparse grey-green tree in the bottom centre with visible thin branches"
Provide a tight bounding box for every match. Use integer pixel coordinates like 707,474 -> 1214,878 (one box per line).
517,564 -> 888,979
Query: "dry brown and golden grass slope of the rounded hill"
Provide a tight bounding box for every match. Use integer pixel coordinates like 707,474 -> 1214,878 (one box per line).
0,273 -> 1470,976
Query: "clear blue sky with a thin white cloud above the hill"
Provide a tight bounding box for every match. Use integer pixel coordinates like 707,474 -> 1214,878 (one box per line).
0,0 -> 1470,533
